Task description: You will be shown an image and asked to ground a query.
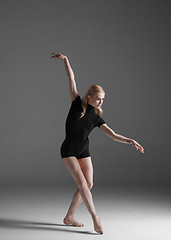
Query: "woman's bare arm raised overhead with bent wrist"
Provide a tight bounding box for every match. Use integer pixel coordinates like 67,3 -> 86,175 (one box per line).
51,53 -> 79,101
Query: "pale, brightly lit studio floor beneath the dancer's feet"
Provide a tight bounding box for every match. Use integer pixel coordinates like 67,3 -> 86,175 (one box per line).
0,185 -> 171,240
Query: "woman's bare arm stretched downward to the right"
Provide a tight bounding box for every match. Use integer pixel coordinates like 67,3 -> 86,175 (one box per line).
100,124 -> 144,153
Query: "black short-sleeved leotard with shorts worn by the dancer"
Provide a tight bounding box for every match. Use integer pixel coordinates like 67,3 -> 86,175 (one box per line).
61,96 -> 105,159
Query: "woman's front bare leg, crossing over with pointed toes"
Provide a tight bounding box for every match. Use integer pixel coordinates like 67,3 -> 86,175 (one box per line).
63,157 -> 103,234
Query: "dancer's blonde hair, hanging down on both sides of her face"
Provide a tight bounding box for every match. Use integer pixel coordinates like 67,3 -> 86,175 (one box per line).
80,84 -> 105,118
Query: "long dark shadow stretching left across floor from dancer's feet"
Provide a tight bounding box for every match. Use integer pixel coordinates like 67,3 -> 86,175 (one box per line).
0,218 -> 98,235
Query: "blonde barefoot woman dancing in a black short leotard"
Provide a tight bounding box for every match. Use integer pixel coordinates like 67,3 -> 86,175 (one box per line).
51,53 -> 144,234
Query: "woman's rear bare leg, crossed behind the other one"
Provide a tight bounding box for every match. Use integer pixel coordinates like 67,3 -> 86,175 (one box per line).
64,157 -> 93,227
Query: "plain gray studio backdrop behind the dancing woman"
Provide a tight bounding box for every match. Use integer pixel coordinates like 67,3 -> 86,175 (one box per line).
0,0 -> 171,184
